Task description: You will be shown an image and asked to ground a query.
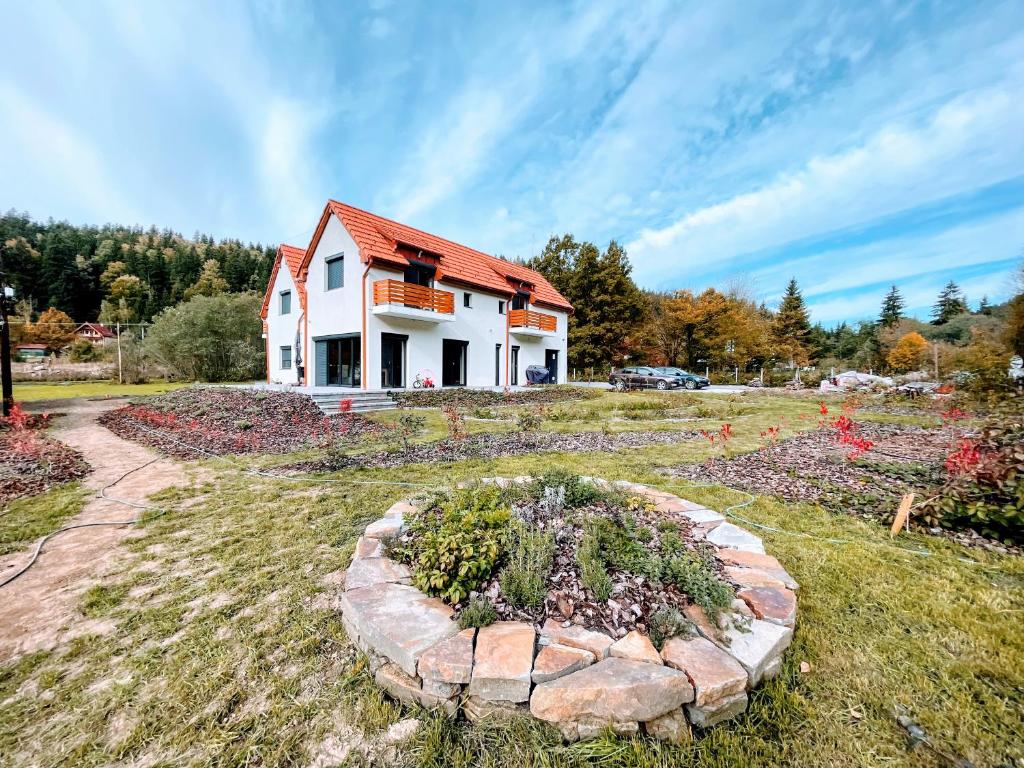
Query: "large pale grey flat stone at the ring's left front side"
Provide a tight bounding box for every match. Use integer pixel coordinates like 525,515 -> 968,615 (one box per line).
341,583 -> 459,675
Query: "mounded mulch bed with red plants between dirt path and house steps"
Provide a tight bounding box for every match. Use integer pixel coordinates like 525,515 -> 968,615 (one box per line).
99,387 -> 389,459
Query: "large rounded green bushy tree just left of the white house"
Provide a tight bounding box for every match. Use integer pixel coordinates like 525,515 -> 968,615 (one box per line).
144,292 -> 265,381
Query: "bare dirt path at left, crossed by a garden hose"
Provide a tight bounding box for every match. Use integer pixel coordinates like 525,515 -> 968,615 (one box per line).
0,399 -> 187,664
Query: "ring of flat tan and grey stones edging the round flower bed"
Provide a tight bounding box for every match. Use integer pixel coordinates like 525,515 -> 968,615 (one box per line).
341,477 -> 798,742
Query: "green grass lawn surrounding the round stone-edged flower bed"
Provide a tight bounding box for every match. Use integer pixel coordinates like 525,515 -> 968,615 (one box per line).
0,394 -> 1024,768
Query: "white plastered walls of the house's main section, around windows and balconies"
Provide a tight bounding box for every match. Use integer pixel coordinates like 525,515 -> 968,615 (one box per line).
306,211 -> 567,389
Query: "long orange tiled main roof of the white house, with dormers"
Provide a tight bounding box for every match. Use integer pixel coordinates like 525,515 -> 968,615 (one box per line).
300,200 -> 572,311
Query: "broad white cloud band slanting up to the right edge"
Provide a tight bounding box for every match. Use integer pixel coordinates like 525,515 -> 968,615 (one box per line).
628,82 -> 1024,286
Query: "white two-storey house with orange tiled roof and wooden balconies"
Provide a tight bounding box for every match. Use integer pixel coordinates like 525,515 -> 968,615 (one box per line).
262,200 -> 572,389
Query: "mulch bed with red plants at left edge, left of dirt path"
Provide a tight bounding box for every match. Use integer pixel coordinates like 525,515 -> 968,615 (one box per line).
0,415 -> 89,507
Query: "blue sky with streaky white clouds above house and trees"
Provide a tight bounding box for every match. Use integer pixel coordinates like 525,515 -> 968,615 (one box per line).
0,0 -> 1024,325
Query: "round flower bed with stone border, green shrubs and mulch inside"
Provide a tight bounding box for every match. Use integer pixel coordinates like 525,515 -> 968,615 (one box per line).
341,473 -> 798,742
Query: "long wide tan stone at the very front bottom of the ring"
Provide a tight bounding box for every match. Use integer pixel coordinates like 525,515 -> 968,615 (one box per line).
529,658 -> 693,724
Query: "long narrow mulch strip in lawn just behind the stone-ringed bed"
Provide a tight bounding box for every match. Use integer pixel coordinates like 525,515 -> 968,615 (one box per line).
286,430 -> 700,472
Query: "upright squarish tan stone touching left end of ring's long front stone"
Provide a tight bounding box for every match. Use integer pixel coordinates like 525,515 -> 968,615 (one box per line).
469,622 -> 537,703
